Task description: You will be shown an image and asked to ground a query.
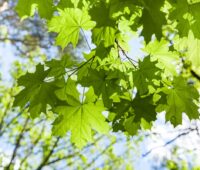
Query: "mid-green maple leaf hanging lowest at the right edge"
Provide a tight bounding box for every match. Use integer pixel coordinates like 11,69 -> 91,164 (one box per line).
159,77 -> 199,126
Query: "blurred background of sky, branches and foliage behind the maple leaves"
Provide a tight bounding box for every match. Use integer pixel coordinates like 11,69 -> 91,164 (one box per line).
0,0 -> 200,170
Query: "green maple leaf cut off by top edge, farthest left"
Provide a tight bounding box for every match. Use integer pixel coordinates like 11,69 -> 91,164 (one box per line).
15,0 -> 54,19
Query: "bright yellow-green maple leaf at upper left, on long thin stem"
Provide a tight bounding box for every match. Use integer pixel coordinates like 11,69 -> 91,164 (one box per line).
48,8 -> 95,48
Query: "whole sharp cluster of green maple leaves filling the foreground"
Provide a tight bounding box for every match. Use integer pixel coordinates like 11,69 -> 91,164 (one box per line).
12,0 -> 200,147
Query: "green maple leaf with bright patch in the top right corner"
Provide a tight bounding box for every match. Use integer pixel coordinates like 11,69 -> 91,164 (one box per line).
169,0 -> 200,38
